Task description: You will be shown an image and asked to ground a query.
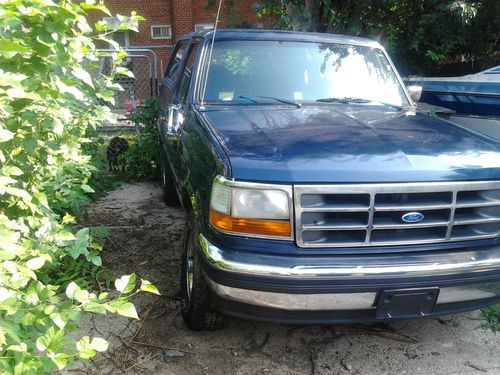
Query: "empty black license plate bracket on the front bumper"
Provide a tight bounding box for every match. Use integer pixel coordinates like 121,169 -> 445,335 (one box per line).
377,287 -> 439,319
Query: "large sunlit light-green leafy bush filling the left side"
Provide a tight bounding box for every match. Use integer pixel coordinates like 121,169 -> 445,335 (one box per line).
0,0 -> 158,374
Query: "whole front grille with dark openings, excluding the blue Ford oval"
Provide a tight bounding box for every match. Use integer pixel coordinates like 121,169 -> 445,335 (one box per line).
294,181 -> 500,247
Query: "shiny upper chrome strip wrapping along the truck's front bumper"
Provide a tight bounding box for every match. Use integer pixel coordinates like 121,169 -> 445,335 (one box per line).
198,233 -> 500,278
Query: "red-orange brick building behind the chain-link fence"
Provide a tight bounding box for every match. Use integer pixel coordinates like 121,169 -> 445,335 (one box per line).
89,0 -> 263,108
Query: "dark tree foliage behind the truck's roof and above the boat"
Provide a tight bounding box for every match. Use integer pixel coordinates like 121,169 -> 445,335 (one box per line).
256,0 -> 500,74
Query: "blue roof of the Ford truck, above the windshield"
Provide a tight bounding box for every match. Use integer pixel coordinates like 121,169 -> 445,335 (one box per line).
181,29 -> 381,48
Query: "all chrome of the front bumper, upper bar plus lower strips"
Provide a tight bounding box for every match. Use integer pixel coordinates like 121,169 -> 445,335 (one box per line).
198,234 -> 500,311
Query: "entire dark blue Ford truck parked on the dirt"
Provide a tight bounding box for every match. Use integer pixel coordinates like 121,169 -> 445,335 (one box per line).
158,30 -> 500,330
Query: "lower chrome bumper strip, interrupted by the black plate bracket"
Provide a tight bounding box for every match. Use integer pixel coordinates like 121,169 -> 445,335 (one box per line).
206,278 -> 500,311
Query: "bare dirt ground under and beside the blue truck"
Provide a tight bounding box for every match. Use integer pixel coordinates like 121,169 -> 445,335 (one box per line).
70,183 -> 500,375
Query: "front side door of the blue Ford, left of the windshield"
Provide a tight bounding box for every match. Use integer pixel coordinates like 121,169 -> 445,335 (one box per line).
167,41 -> 199,185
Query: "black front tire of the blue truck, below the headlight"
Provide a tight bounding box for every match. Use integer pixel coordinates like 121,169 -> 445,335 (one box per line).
181,221 -> 224,331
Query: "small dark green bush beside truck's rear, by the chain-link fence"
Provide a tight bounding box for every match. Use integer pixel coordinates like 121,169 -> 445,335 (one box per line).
125,97 -> 160,179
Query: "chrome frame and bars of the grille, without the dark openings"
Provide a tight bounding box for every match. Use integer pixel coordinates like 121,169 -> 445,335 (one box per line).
293,181 -> 500,248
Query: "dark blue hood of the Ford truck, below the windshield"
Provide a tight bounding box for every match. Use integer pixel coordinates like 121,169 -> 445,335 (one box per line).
202,105 -> 500,183
